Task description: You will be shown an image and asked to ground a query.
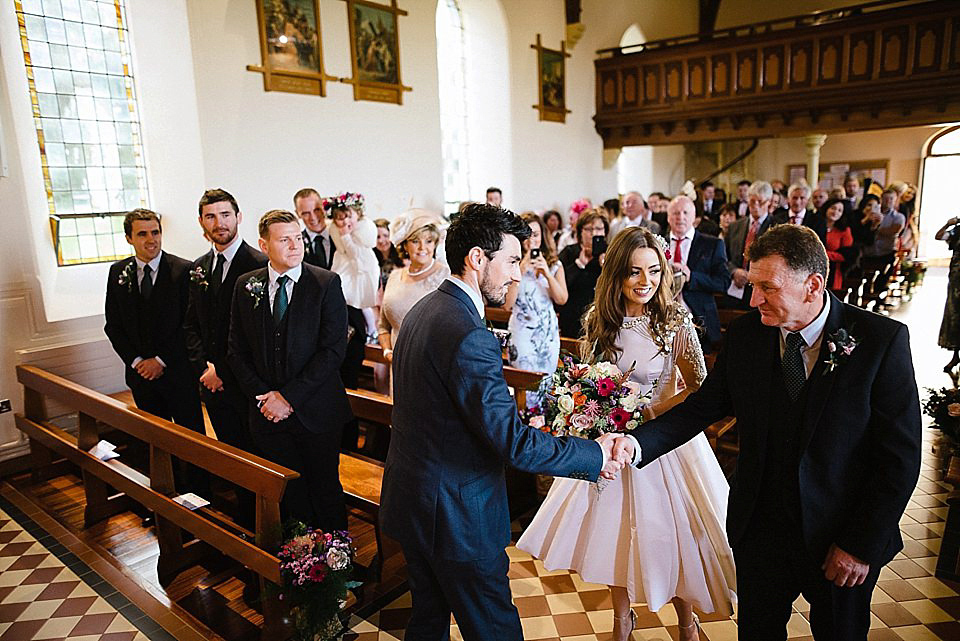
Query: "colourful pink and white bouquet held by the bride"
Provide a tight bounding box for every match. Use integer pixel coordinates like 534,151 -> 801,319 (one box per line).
524,353 -> 650,439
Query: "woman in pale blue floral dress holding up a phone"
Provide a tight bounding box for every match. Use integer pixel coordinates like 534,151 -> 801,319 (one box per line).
504,214 -> 567,400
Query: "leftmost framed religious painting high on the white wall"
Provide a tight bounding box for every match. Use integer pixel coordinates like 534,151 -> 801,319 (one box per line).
247,0 -> 339,96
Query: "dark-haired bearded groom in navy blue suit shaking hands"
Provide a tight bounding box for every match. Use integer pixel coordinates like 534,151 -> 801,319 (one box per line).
380,204 -> 618,641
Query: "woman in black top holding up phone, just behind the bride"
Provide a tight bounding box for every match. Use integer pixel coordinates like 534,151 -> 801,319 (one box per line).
558,209 -> 610,338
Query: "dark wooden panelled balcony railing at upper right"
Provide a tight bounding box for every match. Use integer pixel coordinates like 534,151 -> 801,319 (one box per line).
594,0 -> 960,148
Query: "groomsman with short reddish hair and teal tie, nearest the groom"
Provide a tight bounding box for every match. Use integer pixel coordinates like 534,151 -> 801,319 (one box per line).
227,210 -> 353,531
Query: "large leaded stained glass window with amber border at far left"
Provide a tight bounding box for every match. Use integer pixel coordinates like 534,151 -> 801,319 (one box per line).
14,0 -> 147,265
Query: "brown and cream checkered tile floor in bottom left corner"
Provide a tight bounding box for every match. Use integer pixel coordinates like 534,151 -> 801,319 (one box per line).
0,510 -> 155,641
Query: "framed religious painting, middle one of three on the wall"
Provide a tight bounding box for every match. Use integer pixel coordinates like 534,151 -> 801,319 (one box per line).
340,0 -> 411,105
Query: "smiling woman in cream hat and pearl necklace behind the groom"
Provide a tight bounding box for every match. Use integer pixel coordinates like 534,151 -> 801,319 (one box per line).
377,209 -> 450,392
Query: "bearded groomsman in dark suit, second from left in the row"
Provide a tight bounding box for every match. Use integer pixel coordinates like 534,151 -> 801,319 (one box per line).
184,189 -> 267,525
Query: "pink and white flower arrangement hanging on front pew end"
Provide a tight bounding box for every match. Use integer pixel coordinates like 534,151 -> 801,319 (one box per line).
277,523 -> 360,641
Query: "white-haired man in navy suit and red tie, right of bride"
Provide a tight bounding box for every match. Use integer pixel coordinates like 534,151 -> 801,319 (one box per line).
667,196 -> 730,352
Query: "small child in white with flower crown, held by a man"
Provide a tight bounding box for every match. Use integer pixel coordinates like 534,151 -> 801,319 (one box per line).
323,192 -> 380,382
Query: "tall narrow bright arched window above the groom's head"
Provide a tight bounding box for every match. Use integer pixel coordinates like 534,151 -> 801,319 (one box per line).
437,0 -> 470,214
